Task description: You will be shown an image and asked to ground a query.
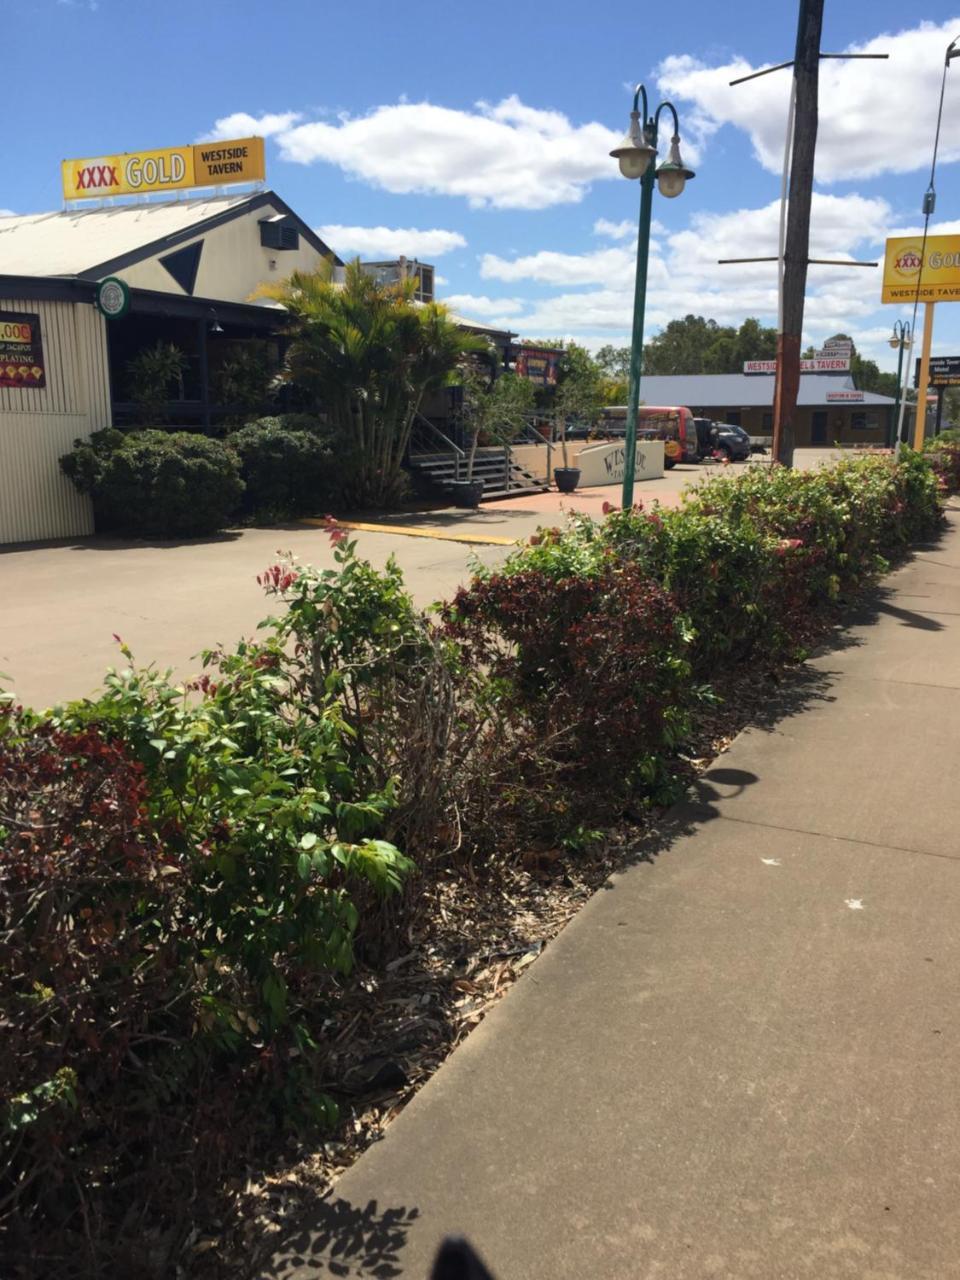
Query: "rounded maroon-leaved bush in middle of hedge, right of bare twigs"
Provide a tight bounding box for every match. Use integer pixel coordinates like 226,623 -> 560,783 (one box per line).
445,552 -> 695,819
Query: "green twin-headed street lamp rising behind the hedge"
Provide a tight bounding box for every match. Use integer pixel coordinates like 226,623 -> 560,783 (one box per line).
611,84 -> 694,511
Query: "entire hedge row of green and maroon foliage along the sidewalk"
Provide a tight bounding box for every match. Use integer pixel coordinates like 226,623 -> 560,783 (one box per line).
0,451 -> 955,1274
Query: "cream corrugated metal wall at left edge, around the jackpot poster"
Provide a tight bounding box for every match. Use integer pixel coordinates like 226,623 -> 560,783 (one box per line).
0,298 -> 110,544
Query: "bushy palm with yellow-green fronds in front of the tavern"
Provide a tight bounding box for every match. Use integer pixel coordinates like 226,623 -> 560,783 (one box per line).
253,260 -> 483,506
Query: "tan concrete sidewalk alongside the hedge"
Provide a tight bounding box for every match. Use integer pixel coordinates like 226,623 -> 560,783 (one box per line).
259,513 -> 960,1280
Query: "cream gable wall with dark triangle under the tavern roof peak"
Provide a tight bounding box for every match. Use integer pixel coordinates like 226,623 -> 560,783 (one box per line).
109,207 -> 324,302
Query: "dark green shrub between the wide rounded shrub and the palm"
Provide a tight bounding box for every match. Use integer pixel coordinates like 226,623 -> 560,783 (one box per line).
227,415 -> 335,517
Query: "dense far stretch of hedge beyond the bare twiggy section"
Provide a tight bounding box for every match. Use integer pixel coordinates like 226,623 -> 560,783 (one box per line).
444,453 -> 942,838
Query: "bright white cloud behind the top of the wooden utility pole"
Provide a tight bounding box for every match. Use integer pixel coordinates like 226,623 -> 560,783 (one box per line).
657,18 -> 960,182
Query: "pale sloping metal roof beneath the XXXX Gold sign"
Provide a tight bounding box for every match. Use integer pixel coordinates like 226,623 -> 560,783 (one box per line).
0,192 -> 251,275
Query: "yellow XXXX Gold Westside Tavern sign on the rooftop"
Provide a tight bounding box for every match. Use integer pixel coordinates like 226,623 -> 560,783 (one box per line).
60,138 -> 266,200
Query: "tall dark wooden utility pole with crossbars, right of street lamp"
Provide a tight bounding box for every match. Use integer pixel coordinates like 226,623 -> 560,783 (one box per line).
773,0 -> 823,467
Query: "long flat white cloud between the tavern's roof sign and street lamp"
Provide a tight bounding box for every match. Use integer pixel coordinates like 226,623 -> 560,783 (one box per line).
232,95 -> 620,209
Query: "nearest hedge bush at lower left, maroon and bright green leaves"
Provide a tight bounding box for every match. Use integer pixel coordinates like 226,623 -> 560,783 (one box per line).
0,614 -> 410,1254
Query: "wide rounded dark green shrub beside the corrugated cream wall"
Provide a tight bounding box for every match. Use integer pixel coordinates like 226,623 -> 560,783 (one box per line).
60,430 -> 243,538
